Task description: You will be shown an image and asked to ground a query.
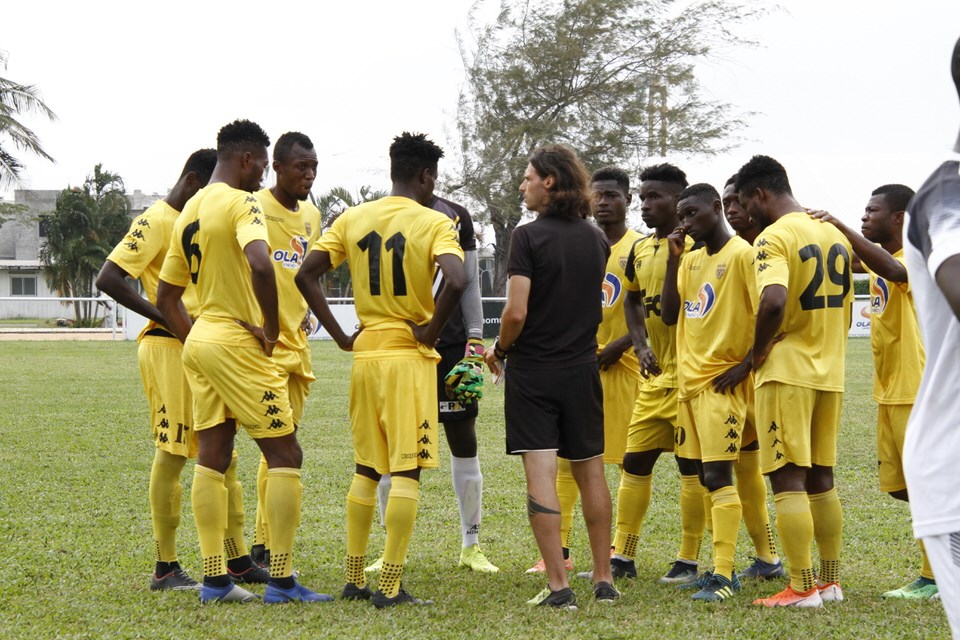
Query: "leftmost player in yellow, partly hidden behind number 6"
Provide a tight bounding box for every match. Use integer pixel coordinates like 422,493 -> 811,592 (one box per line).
97,149 -> 229,591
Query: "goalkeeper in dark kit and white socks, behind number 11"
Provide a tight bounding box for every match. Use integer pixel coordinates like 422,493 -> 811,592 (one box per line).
367,197 -> 499,573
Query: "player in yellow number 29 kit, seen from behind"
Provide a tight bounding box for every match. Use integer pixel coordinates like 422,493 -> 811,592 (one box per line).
736,156 -> 853,607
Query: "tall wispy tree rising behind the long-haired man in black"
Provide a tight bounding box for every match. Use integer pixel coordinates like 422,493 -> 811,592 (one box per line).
451,0 -> 764,292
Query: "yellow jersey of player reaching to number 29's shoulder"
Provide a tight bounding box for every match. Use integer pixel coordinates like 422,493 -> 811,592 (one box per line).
864,249 -> 925,404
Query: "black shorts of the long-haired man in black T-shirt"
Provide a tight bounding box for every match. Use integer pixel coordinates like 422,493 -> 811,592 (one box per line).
504,362 -> 603,461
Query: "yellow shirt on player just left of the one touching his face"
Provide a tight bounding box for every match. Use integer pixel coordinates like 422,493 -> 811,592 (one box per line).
624,235 -> 693,389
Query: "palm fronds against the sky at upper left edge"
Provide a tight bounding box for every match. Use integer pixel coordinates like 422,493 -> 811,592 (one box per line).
0,51 -> 57,190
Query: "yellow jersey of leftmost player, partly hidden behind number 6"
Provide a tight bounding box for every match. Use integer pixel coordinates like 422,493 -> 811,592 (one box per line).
107,200 -> 199,341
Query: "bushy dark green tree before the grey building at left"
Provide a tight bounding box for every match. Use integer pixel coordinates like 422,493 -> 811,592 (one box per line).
40,164 -> 130,326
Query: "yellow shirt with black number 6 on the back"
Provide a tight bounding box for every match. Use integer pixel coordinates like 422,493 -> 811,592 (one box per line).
160,182 -> 269,346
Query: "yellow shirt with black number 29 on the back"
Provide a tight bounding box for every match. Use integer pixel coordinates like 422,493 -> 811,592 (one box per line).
753,212 -> 853,392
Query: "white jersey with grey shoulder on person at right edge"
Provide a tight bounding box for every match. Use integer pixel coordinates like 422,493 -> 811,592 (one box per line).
903,155 -> 960,538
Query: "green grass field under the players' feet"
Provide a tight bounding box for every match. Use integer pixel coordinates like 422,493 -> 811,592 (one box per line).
0,339 -> 949,639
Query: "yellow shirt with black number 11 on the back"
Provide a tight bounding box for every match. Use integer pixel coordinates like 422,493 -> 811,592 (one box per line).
313,196 -> 463,355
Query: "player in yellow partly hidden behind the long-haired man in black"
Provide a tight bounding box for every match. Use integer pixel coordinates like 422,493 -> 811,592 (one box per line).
527,167 -> 642,578
